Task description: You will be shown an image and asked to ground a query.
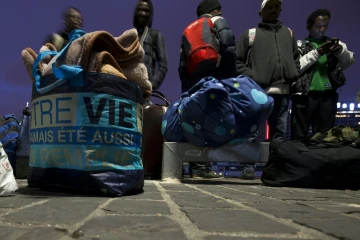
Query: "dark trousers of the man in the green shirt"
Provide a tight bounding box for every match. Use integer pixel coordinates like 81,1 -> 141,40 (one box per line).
291,92 -> 339,140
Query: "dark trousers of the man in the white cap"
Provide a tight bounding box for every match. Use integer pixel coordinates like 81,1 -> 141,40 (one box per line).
268,94 -> 289,140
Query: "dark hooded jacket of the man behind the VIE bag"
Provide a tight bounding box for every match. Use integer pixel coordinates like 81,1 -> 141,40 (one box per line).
133,0 -> 168,90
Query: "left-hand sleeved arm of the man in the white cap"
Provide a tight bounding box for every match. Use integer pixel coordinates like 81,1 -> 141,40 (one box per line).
236,31 -> 253,78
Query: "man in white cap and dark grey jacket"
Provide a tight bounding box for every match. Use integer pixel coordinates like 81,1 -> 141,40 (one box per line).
236,0 -> 300,140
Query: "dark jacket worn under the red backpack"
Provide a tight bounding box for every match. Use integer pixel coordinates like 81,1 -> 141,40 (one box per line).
178,15 -> 236,92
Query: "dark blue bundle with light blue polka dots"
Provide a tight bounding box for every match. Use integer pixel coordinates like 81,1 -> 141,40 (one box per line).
162,76 -> 274,147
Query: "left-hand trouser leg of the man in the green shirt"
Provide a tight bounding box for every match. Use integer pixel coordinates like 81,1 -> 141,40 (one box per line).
291,95 -> 310,140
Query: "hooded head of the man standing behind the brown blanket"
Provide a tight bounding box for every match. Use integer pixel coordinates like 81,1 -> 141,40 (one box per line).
134,0 -> 154,28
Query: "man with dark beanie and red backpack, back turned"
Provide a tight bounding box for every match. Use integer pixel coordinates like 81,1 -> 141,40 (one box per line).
178,0 -> 236,178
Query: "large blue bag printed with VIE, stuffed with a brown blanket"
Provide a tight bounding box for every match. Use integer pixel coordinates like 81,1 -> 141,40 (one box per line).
28,32 -> 144,196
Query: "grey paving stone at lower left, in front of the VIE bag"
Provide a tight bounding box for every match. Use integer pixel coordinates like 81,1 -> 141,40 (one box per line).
3,197 -> 106,225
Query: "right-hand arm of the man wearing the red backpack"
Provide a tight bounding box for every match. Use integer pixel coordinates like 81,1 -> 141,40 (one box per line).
214,17 -> 236,77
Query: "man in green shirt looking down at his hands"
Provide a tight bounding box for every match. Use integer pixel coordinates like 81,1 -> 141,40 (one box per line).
291,9 -> 355,140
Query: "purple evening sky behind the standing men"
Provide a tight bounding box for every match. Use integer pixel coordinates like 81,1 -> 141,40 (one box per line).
0,0 -> 360,116
